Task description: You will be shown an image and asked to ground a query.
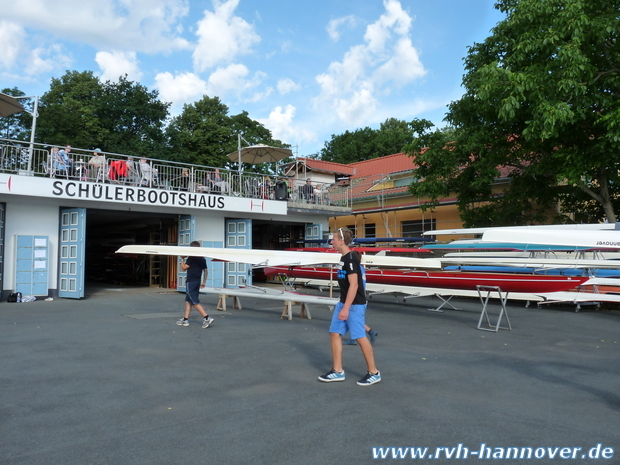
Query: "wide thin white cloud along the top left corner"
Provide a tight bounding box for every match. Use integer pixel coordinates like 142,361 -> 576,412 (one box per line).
2,0 -> 190,53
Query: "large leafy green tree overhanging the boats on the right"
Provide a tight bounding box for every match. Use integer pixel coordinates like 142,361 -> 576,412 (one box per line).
407,0 -> 620,226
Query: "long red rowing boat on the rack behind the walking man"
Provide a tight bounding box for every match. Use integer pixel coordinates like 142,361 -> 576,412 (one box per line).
264,266 -> 588,293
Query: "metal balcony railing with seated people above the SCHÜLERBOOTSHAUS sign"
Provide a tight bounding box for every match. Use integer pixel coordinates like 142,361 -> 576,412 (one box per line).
0,139 -> 351,210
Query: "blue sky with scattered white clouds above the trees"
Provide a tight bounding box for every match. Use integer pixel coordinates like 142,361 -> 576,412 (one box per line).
0,0 -> 503,156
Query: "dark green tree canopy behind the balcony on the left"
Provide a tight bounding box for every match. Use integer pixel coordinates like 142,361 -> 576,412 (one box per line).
7,71 -> 287,172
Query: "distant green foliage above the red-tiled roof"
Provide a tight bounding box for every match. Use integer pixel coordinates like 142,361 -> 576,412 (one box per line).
320,118 -> 413,164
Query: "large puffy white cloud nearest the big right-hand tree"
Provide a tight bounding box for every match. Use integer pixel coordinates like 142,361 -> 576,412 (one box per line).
313,0 -> 426,125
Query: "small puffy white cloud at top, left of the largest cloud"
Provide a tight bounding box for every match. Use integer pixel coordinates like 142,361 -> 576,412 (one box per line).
192,0 -> 260,72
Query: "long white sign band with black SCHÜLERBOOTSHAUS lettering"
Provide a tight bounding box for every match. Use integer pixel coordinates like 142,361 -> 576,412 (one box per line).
0,173 -> 287,215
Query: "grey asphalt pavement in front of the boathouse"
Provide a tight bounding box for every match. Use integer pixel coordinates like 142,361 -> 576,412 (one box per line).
0,282 -> 620,465
